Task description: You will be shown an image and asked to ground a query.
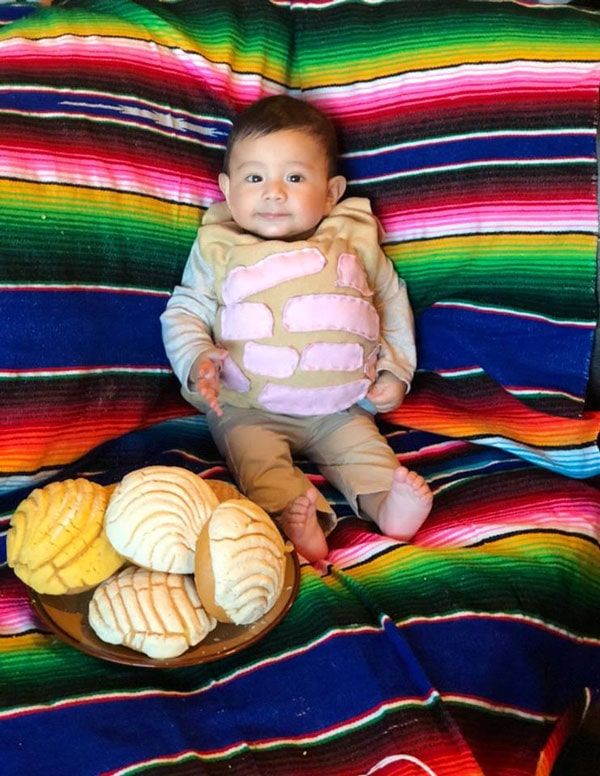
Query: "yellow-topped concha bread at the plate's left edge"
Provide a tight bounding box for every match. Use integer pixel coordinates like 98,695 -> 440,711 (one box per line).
7,478 -> 124,595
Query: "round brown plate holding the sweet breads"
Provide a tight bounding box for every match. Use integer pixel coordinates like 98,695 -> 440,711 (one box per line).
29,552 -> 300,668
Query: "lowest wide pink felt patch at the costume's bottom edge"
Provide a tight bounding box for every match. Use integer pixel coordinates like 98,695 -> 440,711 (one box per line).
257,380 -> 370,415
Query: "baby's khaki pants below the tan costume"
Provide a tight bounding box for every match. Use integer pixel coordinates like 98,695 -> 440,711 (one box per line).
207,406 -> 398,532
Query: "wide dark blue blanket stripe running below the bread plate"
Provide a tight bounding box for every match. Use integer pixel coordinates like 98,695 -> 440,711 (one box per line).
3,613 -> 600,776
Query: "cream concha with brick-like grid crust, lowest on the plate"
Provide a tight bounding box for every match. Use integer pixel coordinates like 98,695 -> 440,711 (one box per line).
88,566 -> 217,660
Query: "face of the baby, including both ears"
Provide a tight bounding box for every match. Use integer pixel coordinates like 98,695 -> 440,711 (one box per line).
219,129 -> 346,240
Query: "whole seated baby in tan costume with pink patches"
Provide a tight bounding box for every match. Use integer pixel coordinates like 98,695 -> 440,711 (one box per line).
161,96 -> 432,562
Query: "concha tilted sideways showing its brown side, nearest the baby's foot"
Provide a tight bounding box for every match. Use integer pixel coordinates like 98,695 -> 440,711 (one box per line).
195,499 -> 285,625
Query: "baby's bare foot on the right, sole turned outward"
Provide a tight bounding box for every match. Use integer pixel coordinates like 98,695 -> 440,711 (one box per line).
374,466 -> 433,542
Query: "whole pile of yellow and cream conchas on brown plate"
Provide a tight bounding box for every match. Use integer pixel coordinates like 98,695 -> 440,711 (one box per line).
7,466 -> 286,659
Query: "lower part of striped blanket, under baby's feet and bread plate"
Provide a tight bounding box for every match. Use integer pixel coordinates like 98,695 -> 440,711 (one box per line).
0,417 -> 600,776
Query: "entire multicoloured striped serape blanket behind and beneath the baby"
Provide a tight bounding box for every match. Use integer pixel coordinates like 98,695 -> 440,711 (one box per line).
0,0 -> 600,776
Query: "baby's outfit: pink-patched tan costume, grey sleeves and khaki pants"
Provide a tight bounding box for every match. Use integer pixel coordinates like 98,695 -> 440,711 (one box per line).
162,198 -> 415,530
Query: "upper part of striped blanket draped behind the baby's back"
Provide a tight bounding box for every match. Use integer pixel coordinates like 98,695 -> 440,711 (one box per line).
0,0 -> 600,490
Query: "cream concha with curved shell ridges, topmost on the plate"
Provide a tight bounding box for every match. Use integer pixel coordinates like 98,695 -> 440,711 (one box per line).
105,466 -> 219,574
